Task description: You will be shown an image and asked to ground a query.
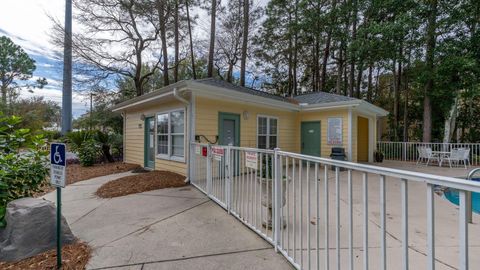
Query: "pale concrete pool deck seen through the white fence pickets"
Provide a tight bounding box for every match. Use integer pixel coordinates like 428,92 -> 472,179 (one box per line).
218,161 -> 480,270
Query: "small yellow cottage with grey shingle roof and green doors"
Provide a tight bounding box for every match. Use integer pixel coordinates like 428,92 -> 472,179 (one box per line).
113,78 -> 387,175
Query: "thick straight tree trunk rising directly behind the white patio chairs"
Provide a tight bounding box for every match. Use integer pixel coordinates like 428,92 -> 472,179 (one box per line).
423,0 -> 438,142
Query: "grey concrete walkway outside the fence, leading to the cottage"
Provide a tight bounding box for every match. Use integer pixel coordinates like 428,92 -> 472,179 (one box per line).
44,173 -> 293,269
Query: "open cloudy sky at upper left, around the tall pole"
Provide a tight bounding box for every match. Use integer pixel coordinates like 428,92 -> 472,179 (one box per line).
0,0 -> 93,117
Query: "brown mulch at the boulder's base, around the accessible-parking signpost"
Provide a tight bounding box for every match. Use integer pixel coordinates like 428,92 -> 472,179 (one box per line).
0,242 -> 92,270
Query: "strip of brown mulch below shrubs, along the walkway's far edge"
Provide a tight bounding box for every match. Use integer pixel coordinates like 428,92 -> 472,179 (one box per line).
34,162 -> 142,197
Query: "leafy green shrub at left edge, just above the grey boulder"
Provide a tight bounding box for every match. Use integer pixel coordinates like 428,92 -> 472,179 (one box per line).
0,115 -> 48,227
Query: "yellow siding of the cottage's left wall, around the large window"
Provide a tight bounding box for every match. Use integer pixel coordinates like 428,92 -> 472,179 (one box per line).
124,101 -> 189,175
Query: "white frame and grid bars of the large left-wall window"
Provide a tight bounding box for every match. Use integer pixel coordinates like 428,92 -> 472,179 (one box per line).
155,108 -> 187,163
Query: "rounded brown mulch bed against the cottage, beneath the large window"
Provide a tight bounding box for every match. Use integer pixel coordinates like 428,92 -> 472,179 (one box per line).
95,171 -> 187,198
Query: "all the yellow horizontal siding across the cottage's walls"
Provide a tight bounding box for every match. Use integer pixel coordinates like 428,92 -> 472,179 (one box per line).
124,92 -> 377,175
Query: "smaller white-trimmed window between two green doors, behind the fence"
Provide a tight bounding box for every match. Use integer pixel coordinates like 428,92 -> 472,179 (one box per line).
257,116 -> 278,149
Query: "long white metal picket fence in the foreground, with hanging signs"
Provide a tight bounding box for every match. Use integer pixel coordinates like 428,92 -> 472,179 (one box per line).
190,143 -> 480,269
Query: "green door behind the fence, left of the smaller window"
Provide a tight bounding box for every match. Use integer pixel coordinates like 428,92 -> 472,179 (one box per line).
218,112 -> 240,146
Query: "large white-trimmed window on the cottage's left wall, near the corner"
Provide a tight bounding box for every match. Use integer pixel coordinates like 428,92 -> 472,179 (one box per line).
157,110 -> 185,159
